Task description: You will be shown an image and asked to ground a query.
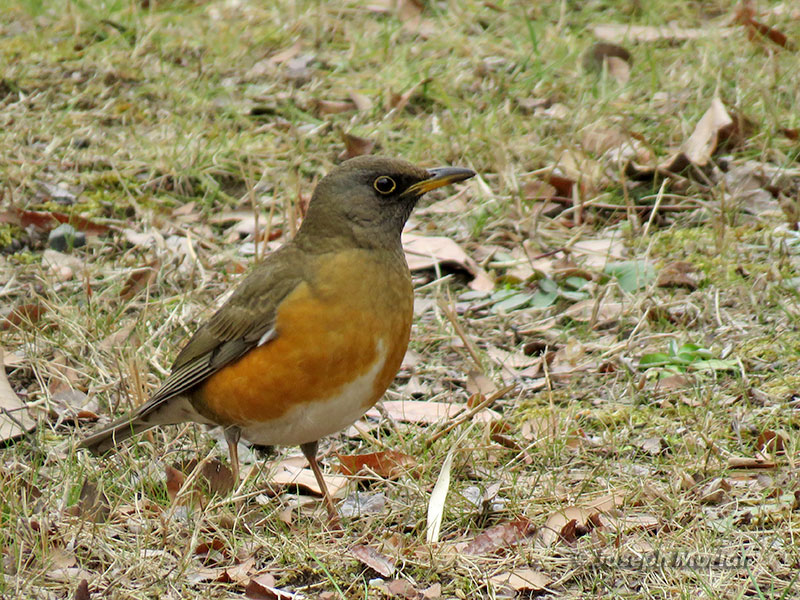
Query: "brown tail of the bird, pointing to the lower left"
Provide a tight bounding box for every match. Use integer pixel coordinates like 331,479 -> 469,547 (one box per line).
78,396 -> 209,455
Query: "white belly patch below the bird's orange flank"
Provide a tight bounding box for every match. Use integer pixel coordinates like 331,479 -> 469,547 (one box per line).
242,341 -> 386,446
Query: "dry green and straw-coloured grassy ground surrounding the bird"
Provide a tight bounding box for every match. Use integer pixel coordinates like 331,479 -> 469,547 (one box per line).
0,0 -> 800,598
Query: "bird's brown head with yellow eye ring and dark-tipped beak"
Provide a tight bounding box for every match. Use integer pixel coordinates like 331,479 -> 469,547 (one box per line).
298,156 -> 475,247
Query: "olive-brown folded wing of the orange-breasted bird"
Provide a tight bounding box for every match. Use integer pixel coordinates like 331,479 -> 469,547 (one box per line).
148,246 -> 304,404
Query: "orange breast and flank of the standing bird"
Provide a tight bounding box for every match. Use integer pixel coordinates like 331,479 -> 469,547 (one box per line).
195,250 -> 413,426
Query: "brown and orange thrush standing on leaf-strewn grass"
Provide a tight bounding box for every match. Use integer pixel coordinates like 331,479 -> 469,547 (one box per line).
79,156 -> 475,525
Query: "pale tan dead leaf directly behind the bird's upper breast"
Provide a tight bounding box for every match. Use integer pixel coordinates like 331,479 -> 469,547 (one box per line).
403,233 -> 494,291
